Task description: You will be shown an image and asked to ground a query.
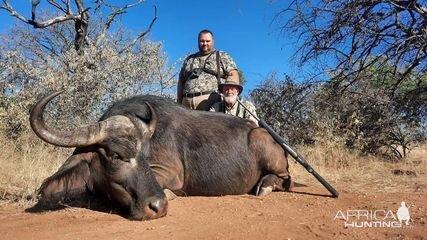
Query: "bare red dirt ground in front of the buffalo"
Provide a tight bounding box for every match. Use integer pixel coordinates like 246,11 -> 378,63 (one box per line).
0,184 -> 427,240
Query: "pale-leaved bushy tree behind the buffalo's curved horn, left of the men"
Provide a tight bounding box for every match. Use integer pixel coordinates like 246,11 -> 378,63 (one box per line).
0,1 -> 176,137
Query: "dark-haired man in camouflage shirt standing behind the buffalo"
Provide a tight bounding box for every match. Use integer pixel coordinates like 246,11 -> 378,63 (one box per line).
177,29 -> 240,111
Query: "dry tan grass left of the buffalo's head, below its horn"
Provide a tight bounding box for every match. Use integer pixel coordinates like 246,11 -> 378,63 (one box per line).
0,135 -> 71,204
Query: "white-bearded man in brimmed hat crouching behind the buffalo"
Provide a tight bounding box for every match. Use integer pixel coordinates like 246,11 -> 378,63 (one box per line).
210,77 -> 258,125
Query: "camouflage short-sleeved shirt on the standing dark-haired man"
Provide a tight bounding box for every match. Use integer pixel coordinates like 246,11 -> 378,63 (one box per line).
179,51 -> 237,93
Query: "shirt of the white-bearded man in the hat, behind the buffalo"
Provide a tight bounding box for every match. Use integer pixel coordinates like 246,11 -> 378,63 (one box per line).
210,100 -> 258,125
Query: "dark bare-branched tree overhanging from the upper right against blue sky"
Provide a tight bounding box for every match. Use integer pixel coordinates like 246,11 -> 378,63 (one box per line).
276,0 -> 427,94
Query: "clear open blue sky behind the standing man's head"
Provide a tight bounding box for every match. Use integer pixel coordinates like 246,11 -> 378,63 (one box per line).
0,0 -> 297,95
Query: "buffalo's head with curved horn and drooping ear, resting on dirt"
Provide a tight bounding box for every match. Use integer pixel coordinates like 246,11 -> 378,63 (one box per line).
30,92 -> 168,220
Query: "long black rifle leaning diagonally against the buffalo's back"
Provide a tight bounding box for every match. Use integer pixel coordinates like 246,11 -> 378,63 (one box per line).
237,98 -> 339,198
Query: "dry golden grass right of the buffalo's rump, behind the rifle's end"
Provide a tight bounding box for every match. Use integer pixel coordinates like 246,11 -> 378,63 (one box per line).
290,144 -> 427,192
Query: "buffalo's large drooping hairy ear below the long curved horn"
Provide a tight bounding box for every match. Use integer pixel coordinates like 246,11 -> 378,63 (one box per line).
38,155 -> 92,203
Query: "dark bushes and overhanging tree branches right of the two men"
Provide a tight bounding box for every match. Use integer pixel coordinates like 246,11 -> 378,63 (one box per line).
252,0 -> 427,159
